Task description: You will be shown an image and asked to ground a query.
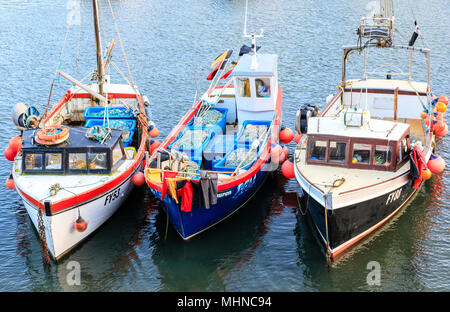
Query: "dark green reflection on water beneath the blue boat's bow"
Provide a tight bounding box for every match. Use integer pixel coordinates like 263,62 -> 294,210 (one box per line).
152,174 -> 279,291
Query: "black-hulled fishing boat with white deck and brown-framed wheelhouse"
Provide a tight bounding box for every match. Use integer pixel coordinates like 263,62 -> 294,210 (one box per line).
294,1 -> 448,260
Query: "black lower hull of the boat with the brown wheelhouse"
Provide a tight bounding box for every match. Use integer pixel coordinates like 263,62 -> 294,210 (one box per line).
298,182 -> 417,258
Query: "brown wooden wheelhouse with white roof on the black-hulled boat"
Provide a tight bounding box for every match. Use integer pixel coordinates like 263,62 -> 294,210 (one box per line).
306,117 -> 410,171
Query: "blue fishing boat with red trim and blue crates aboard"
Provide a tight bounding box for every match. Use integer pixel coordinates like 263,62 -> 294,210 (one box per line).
145,23 -> 283,240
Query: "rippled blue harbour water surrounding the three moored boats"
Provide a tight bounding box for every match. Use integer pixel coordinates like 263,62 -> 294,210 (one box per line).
0,0 -> 450,292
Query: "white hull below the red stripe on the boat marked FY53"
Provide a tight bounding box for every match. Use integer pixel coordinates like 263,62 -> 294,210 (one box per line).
18,172 -> 134,260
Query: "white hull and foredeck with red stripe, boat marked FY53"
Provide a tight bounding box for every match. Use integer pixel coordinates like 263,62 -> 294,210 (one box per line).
13,158 -> 139,260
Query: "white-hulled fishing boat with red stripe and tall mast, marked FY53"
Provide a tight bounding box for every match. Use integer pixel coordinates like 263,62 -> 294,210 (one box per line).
5,0 -> 153,260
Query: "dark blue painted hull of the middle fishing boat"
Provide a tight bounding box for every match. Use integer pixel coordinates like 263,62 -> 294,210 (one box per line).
150,158 -> 270,239
